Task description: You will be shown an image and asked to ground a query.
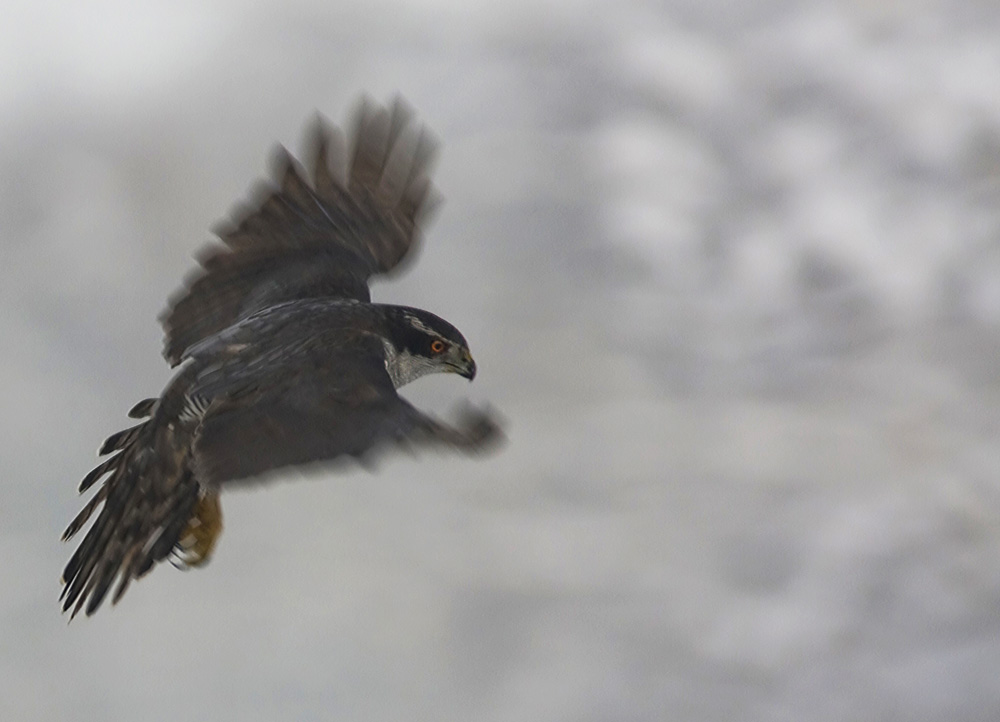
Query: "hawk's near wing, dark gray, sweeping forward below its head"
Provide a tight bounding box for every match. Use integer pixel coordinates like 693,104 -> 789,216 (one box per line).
192,336 -> 498,485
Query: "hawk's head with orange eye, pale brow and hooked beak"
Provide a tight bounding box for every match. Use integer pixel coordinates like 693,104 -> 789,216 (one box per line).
385,306 -> 476,388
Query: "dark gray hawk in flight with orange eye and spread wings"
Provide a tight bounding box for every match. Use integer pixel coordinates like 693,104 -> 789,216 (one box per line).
61,94 -> 501,618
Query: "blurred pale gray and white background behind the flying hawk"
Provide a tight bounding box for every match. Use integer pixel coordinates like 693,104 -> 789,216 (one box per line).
0,0 -> 1000,722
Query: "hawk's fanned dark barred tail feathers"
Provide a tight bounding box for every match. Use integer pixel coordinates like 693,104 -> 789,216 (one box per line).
60,399 -> 200,618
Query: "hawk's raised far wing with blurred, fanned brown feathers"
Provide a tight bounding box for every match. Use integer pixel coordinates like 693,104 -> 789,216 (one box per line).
161,99 -> 435,365
